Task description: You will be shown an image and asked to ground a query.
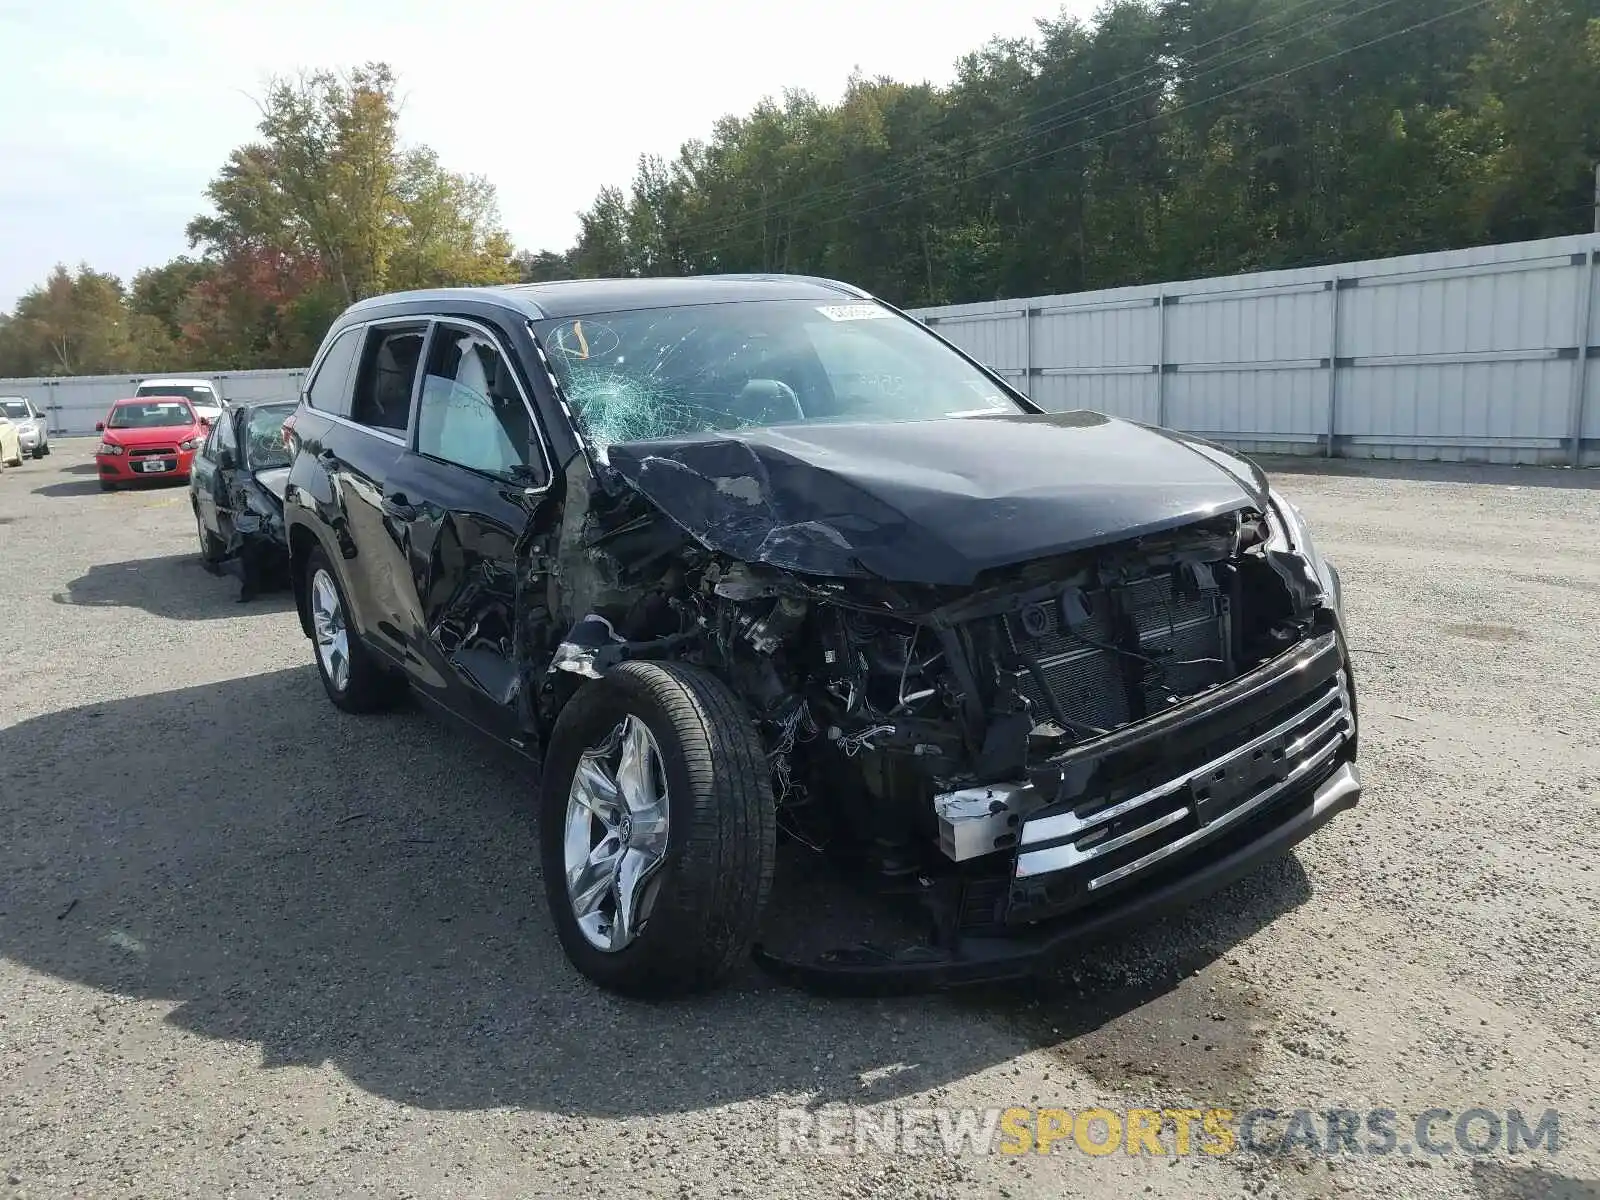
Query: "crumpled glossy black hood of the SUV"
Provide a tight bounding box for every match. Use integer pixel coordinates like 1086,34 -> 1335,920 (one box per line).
608,413 -> 1267,586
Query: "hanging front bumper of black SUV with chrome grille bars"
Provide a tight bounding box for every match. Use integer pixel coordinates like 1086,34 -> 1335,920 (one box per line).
757,629 -> 1362,992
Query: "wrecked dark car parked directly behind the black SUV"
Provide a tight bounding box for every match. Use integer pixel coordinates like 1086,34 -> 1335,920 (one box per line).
189,402 -> 294,600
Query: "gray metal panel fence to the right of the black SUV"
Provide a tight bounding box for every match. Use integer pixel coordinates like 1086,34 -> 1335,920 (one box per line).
915,235 -> 1600,466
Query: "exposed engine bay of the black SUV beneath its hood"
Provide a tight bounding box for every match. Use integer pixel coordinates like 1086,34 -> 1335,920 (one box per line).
537,464 -> 1318,875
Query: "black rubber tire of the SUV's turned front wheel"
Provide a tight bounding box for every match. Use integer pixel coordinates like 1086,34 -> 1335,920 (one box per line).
539,661 -> 778,998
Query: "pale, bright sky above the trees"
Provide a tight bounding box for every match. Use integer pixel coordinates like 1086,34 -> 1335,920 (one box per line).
0,0 -> 1096,309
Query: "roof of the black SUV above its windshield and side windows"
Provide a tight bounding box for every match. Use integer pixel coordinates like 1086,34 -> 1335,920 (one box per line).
350,275 -> 867,320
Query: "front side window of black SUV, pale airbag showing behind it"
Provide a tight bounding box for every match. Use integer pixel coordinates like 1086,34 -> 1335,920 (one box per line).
416,325 -> 542,482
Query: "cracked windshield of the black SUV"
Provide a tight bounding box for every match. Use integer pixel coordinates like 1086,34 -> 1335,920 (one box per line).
534,301 -> 1021,448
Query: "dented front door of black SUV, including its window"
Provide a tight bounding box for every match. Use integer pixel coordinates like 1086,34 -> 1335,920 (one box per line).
389,318 -> 563,749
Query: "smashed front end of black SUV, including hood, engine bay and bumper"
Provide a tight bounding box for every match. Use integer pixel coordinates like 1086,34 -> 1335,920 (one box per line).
541,347 -> 1360,989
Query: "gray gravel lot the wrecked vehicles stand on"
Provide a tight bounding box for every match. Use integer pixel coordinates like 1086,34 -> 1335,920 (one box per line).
0,440 -> 1600,1200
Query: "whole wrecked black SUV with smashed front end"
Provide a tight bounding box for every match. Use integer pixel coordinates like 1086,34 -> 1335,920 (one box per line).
285,277 -> 1360,994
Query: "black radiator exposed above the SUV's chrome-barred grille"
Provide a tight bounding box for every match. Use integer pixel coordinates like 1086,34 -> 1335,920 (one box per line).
1000,574 -> 1227,730
